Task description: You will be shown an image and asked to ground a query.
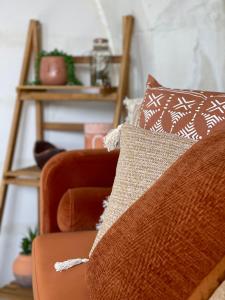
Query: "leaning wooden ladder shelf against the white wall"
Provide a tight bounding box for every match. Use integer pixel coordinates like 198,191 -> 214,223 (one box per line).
0,16 -> 134,226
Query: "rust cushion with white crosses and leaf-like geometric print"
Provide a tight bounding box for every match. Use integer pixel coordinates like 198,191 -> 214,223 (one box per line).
139,75 -> 225,140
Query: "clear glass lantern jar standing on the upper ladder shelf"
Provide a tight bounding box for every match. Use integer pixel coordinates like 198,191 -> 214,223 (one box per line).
91,38 -> 111,87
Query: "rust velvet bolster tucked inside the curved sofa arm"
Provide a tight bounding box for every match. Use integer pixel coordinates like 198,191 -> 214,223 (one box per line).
57,187 -> 112,232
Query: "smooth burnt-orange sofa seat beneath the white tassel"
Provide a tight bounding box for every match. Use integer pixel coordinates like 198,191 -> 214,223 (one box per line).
32,231 -> 96,300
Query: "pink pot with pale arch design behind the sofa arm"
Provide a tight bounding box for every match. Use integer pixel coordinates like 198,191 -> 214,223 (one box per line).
84,123 -> 112,149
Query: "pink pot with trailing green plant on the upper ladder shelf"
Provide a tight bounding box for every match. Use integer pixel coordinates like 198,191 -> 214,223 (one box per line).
34,49 -> 82,85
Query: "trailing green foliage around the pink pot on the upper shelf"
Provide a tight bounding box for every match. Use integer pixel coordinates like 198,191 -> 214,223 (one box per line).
34,49 -> 82,85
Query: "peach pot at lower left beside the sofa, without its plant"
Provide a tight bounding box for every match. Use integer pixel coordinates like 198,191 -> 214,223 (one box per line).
13,254 -> 32,287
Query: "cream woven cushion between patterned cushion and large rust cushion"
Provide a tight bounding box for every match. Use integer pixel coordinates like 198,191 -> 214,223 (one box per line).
90,124 -> 194,255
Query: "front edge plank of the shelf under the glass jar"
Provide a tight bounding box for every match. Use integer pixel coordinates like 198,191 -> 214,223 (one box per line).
20,92 -> 117,102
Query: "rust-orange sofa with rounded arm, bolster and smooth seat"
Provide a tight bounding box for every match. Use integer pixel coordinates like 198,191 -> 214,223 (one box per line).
32,150 -> 119,300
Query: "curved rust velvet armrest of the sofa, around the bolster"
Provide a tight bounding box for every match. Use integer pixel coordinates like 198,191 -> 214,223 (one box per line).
40,149 -> 119,233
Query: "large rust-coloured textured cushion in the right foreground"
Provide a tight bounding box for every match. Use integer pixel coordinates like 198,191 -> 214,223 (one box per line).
87,131 -> 225,300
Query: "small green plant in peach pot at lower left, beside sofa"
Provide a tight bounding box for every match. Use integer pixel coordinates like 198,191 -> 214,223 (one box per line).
13,228 -> 37,287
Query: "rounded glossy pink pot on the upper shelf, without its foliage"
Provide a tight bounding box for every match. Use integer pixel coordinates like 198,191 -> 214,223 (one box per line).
39,56 -> 67,85
